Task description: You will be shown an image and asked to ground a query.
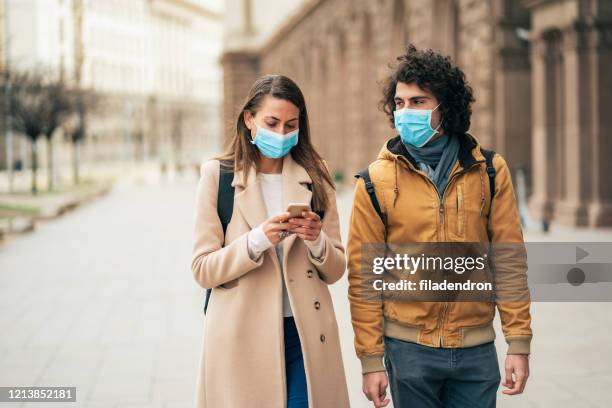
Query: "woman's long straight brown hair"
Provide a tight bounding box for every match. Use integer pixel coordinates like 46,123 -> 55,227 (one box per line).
215,75 -> 335,211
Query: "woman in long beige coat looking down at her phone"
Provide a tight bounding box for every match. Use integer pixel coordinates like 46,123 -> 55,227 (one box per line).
191,75 -> 349,408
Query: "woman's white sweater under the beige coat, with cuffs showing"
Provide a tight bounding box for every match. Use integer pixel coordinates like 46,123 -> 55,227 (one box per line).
247,173 -> 325,317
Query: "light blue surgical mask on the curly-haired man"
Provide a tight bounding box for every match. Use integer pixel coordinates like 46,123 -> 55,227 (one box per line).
393,104 -> 442,147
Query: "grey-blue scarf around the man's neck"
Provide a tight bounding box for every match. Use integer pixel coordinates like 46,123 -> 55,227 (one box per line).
404,134 -> 459,198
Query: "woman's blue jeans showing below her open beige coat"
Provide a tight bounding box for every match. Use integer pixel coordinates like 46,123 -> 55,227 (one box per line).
283,316 -> 308,408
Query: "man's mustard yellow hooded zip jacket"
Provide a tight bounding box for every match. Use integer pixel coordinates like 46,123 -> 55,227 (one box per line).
347,134 -> 532,373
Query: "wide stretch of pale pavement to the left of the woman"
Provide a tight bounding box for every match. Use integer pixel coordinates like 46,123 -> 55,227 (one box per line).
0,167 -> 203,408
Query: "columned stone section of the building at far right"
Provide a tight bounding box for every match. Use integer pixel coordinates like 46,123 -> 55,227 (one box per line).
523,0 -> 612,226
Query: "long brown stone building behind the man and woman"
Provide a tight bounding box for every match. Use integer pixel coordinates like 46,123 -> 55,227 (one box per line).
222,0 -> 612,230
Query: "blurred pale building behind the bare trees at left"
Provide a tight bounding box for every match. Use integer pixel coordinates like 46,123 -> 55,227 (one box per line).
0,0 -> 223,179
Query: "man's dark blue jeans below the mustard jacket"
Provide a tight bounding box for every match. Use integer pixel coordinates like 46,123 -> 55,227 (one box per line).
384,336 -> 501,408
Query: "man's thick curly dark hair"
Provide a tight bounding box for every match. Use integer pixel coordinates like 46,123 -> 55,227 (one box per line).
379,44 -> 475,134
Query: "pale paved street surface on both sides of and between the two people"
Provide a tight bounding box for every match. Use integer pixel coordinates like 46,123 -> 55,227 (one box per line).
0,167 -> 612,408
